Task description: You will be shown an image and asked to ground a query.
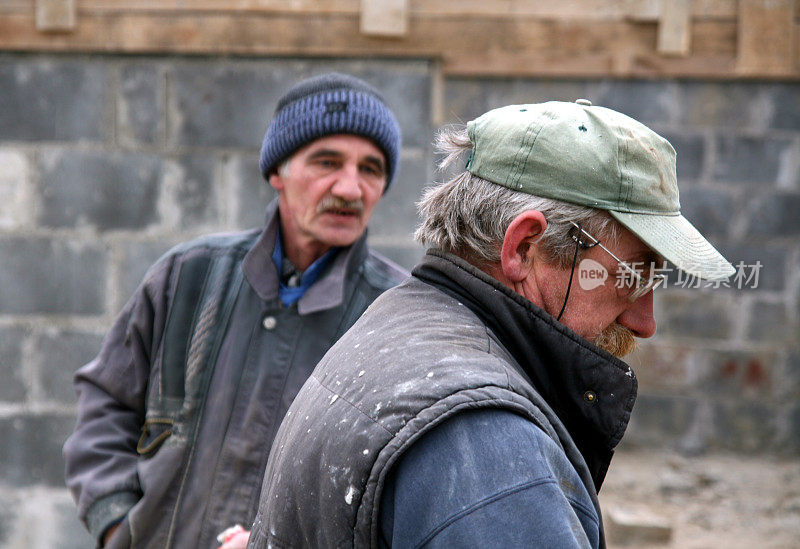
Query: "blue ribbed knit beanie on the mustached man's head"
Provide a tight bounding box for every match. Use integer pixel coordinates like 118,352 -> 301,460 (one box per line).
260,72 -> 400,189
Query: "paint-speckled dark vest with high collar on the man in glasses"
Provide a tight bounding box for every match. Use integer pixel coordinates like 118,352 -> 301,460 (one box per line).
248,250 -> 637,549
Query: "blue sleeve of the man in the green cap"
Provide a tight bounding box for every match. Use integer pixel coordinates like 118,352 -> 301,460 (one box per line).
378,408 -> 600,549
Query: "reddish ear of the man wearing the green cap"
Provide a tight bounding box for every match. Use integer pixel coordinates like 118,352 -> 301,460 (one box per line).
500,210 -> 547,282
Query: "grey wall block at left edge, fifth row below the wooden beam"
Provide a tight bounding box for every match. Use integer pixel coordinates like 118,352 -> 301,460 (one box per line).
0,414 -> 75,487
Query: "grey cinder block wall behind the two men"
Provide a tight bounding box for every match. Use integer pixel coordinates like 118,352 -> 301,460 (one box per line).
0,50 -> 800,548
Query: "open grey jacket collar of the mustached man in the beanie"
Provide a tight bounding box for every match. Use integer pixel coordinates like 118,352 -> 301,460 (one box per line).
242,198 -> 367,315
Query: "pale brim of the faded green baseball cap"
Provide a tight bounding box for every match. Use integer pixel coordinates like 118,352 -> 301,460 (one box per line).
608,211 -> 736,280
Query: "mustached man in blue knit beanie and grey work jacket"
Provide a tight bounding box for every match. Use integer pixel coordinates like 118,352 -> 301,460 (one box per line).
64,73 -> 406,549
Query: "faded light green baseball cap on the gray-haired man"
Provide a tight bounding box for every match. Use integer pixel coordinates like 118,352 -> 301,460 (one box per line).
467,99 -> 735,280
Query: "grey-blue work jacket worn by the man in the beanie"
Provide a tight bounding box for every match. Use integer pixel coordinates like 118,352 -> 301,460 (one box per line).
64,201 -> 406,549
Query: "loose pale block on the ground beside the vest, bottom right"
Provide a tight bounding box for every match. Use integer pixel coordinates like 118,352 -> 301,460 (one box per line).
603,506 -> 672,547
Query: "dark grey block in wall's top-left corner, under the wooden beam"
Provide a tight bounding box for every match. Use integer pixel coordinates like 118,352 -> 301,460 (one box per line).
0,56 -> 111,141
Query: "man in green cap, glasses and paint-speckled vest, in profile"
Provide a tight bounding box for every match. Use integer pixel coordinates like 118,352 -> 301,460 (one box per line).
248,100 -> 734,548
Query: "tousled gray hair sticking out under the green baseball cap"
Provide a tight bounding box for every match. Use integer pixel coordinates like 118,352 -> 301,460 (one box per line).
414,126 -> 617,266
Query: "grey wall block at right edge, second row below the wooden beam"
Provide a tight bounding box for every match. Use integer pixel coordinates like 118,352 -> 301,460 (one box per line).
711,135 -> 795,184
